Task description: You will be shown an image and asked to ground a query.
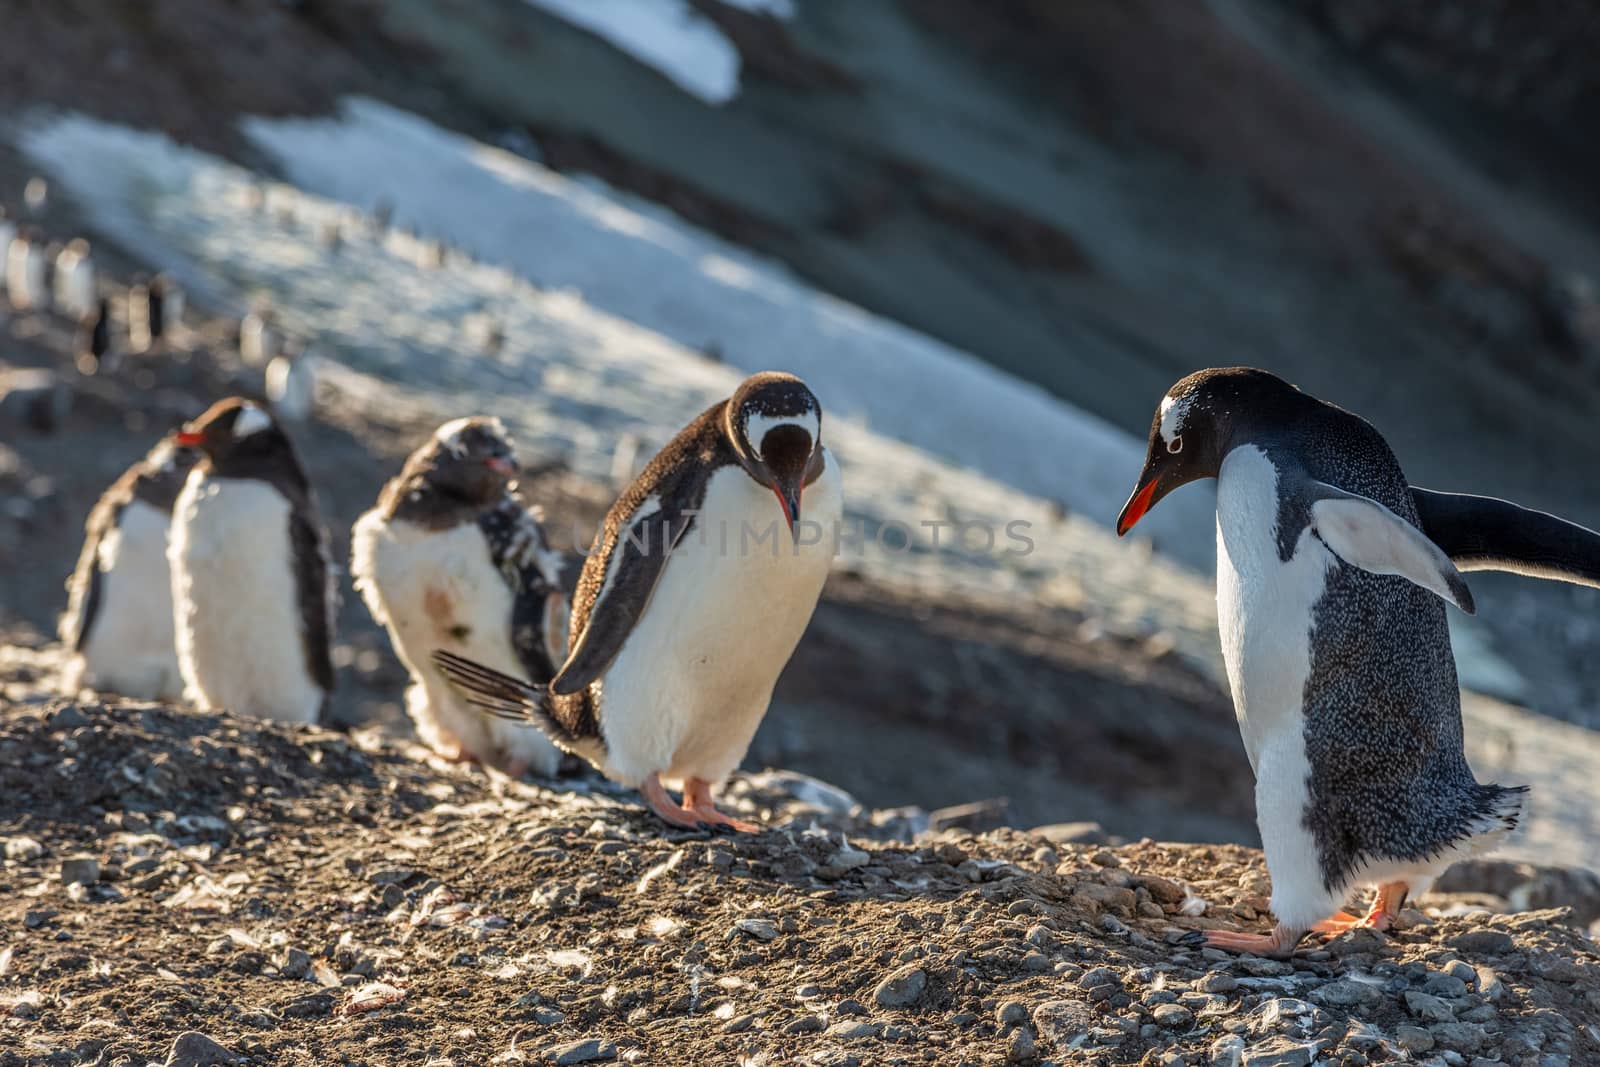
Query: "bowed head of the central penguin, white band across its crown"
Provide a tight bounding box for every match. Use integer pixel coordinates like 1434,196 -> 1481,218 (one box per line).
726,371 -> 822,533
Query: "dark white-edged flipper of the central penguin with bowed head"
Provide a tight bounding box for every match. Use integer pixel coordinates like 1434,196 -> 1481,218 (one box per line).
550,496 -> 694,696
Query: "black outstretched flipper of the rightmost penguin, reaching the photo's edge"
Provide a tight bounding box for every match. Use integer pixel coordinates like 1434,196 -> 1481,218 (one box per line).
1411,485 -> 1600,589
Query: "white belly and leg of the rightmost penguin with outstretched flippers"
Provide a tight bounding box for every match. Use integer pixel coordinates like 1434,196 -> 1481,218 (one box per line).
1216,446 -> 1339,928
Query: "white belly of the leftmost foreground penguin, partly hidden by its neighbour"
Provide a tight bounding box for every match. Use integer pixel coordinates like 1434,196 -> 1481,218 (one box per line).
78,499 -> 184,701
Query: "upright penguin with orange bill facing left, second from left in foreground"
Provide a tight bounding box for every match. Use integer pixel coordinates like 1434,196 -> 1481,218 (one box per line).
168,397 -> 334,723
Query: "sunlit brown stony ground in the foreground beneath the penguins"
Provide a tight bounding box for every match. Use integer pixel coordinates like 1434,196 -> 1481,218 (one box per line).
0,694 -> 1600,1067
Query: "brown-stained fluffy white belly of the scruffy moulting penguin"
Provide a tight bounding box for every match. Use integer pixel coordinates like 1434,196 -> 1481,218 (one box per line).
350,512 -> 562,776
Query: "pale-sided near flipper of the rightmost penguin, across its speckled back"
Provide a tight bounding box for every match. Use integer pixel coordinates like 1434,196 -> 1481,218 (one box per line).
1309,482 -> 1475,614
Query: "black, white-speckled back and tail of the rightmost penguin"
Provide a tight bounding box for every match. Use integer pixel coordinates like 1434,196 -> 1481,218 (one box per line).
1253,394 -> 1509,888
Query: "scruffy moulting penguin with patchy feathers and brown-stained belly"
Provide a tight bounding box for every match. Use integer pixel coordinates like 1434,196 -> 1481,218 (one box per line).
350,416 -> 571,777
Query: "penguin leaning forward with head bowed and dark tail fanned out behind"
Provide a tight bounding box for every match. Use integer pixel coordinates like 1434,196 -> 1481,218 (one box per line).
435,373 -> 843,832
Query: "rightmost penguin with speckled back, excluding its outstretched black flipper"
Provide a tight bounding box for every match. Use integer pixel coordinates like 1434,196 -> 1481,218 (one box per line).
1117,368 -> 1525,957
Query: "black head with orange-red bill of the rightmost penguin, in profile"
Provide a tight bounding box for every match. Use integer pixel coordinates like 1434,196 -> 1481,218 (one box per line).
1117,366 -> 1304,537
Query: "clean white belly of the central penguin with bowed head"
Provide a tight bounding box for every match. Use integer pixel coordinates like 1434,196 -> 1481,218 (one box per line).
600,456 -> 843,785
